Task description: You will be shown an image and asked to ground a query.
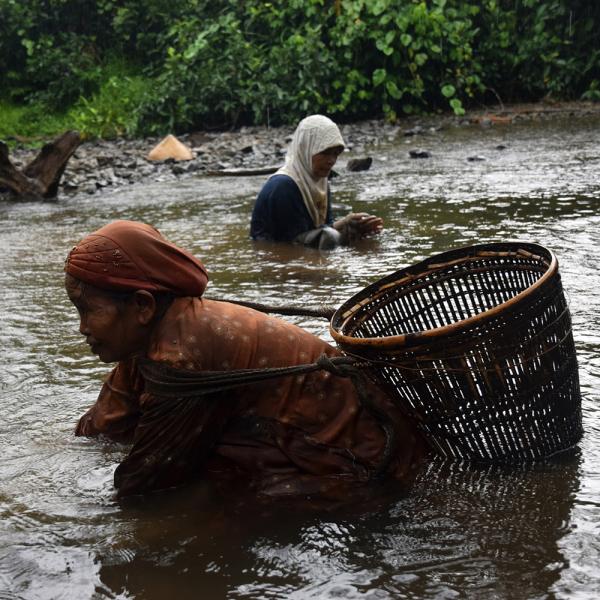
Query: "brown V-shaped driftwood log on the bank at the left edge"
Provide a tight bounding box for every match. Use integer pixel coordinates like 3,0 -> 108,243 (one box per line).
0,131 -> 82,200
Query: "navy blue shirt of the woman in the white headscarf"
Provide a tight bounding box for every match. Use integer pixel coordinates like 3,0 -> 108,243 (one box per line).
250,175 -> 333,242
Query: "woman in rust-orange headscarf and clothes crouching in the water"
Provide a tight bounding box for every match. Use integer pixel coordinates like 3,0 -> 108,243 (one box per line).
65,221 -> 426,496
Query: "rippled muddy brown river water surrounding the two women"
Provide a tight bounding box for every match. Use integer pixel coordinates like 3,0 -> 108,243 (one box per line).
0,119 -> 600,600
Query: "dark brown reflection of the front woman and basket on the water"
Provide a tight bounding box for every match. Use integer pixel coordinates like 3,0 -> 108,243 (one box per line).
92,457 -> 579,599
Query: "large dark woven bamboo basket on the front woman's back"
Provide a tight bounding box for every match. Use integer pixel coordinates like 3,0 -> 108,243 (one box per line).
330,242 -> 582,463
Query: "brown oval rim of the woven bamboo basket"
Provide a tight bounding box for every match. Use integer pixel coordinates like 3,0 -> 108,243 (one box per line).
329,241 -> 558,349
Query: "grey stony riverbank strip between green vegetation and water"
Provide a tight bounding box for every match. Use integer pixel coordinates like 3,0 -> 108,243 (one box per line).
4,102 -> 600,197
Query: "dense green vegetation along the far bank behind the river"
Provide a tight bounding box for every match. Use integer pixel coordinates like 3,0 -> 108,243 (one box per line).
0,0 -> 600,138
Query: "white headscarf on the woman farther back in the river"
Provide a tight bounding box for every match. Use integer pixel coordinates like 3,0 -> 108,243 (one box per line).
275,115 -> 346,227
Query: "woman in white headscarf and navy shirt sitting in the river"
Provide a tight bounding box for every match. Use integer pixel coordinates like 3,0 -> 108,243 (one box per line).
250,115 -> 383,249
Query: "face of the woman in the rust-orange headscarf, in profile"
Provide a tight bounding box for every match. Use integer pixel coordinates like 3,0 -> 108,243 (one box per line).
65,275 -> 150,363
